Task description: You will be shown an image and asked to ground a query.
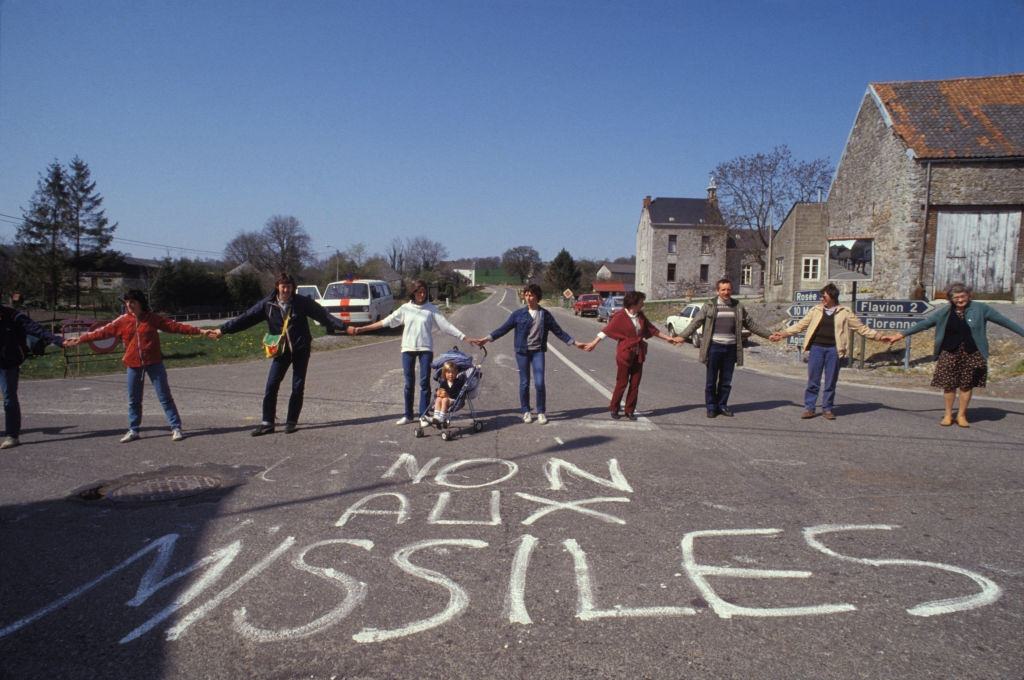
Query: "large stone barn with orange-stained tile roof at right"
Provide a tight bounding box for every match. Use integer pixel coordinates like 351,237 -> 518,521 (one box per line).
823,74 -> 1024,301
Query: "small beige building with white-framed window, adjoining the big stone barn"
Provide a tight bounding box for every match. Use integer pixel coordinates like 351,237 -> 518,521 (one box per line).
765,203 -> 828,302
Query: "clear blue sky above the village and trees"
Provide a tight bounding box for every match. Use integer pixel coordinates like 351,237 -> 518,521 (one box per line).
0,0 -> 1024,258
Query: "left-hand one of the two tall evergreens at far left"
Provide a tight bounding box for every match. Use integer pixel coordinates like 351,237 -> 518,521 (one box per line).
16,161 -> 69,309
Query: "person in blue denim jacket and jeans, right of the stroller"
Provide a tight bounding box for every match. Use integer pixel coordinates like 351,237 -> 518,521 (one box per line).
480,284 -> 584,425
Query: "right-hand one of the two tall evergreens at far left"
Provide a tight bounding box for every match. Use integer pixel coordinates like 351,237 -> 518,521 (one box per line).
65,156 -> 118,309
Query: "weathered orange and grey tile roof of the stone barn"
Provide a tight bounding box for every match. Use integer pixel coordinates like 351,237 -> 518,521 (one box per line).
870,73 -> 1024,159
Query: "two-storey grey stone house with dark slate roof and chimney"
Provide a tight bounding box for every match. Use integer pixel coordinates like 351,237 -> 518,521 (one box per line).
635,183 -> 728,300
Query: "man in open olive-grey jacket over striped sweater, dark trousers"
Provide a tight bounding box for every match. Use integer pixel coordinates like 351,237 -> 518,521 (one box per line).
680,279 -> 771,418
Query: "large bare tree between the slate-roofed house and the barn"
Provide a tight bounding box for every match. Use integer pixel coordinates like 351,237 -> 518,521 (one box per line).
714,144 -> 833,266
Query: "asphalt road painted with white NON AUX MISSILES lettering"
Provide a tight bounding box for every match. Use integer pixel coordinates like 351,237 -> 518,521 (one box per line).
0,291 -> 1024,680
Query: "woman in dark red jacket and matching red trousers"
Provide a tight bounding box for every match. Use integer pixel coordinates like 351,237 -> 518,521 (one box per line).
583,291 -> 683,420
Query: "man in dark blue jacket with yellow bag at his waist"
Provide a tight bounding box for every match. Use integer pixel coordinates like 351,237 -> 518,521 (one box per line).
216,273 -> 347,437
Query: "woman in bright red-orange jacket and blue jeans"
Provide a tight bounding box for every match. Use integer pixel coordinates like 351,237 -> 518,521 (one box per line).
66,290 -> 212,443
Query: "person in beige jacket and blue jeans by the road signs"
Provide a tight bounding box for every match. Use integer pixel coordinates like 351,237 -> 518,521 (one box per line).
769,284 -> 888,420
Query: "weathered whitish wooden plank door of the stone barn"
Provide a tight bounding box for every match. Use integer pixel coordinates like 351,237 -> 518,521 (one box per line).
935,210 -> 1021,294
